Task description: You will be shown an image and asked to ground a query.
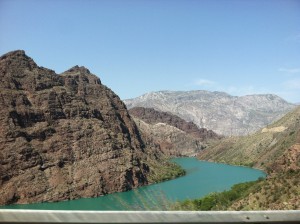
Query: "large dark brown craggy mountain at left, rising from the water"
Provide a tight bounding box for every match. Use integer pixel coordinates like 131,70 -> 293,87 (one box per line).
0,50 -> 182,204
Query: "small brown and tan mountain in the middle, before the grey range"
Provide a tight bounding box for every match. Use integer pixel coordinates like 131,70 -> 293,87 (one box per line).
129,107 -> 220,156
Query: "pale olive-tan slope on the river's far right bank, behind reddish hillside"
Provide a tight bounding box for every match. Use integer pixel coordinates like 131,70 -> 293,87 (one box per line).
199,107 -> 300,173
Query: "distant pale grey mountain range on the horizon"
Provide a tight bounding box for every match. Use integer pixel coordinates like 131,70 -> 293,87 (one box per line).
124,90 -> 295,136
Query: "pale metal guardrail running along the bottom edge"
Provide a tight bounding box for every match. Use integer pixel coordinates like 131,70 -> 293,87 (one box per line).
0,209 -> 300,224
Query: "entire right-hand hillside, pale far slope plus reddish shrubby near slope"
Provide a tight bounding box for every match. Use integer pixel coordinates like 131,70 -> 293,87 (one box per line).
198,107 -> 300,210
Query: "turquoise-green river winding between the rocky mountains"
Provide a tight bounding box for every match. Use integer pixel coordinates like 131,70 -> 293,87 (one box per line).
0,158 -> 265,210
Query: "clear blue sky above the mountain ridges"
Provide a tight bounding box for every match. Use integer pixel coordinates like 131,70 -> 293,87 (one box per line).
0,0 -> 300,102
